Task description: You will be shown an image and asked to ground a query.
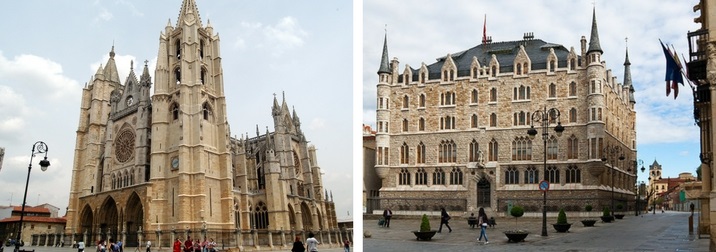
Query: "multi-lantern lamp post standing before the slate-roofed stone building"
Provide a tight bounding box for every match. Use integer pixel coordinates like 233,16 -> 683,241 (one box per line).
527,106 -> 564,236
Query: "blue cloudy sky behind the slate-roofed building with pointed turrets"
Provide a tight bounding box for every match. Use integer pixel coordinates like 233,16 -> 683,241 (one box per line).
362,0 -> 700,185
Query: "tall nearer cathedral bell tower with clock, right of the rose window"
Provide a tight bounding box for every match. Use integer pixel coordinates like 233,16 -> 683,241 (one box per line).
146,0 -> 234,230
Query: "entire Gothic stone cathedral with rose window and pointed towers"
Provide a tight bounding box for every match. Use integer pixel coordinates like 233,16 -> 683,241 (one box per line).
66,0 -> 341,249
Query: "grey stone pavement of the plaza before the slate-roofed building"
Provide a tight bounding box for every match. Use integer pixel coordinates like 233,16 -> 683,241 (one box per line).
363,211 -> 709,252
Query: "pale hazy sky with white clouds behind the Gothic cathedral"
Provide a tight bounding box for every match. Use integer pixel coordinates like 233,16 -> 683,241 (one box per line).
0,0 -> 353,219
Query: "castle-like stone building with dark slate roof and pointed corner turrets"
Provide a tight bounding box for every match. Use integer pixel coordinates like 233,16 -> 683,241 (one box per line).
375,8 -> 636,218
